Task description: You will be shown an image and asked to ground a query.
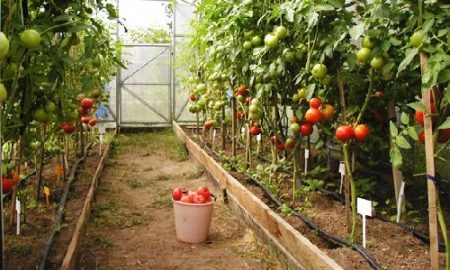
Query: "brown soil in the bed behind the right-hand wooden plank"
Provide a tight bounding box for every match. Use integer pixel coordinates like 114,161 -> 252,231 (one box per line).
185,129 -> 445,269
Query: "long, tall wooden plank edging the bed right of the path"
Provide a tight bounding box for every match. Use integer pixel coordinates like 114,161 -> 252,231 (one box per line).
173,122 -> 343,270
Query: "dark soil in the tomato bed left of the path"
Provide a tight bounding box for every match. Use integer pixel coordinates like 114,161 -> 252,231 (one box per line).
5,141 -> 99,270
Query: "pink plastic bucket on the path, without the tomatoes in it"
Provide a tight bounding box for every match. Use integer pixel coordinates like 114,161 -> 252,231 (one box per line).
173,200 -> 214,243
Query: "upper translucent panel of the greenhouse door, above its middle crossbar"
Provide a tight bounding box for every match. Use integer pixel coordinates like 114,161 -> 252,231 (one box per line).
121,46 -> 170,84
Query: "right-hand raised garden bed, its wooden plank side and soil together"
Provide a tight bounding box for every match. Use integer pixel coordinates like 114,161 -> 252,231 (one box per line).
173,123 -> 444,269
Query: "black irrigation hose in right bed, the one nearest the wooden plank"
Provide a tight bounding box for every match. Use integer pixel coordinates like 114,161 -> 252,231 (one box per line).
196,138 -> 383,270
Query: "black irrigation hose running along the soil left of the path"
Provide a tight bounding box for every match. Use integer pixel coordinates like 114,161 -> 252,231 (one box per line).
36,143 -> 92,270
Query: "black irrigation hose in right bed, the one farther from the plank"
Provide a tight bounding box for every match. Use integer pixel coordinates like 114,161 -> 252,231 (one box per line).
221,133 -> 445,252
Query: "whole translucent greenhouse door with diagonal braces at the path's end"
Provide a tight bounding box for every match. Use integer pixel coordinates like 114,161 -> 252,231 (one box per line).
117,45 -> 172,127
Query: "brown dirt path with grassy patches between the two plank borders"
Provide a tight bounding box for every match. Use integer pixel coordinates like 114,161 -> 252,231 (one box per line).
79,130 -> 280,269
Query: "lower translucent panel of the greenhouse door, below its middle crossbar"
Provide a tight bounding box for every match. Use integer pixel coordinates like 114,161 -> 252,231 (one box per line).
121,85 -> 170,123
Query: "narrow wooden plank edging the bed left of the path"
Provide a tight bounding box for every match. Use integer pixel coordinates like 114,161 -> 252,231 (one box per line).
60,137 -> 115,270
